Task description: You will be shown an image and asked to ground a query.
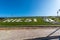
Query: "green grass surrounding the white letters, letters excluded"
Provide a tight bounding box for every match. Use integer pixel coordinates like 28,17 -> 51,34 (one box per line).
0,17 -> 60,26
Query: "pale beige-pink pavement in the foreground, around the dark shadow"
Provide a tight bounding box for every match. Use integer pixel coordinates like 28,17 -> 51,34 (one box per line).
0,27 -> 60,40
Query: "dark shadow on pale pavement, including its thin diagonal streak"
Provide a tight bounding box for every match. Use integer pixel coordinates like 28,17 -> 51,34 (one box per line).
25,27 -> 60,40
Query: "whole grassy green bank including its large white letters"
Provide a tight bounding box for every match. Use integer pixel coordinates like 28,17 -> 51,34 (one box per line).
0,16 -> 60,26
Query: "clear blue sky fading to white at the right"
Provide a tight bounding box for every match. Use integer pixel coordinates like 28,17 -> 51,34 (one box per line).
0,0 -> 60,17
